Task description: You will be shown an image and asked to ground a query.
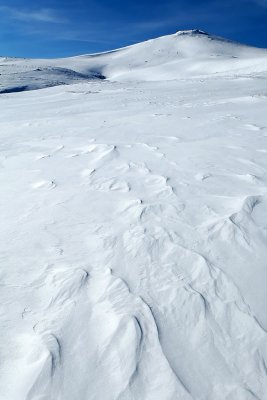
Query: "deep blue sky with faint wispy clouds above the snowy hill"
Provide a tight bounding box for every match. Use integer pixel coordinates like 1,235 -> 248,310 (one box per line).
0,0 -> 267,57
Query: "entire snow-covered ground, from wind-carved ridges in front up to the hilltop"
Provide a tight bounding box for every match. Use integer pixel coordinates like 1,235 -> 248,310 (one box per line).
0,31 -> 267,400
